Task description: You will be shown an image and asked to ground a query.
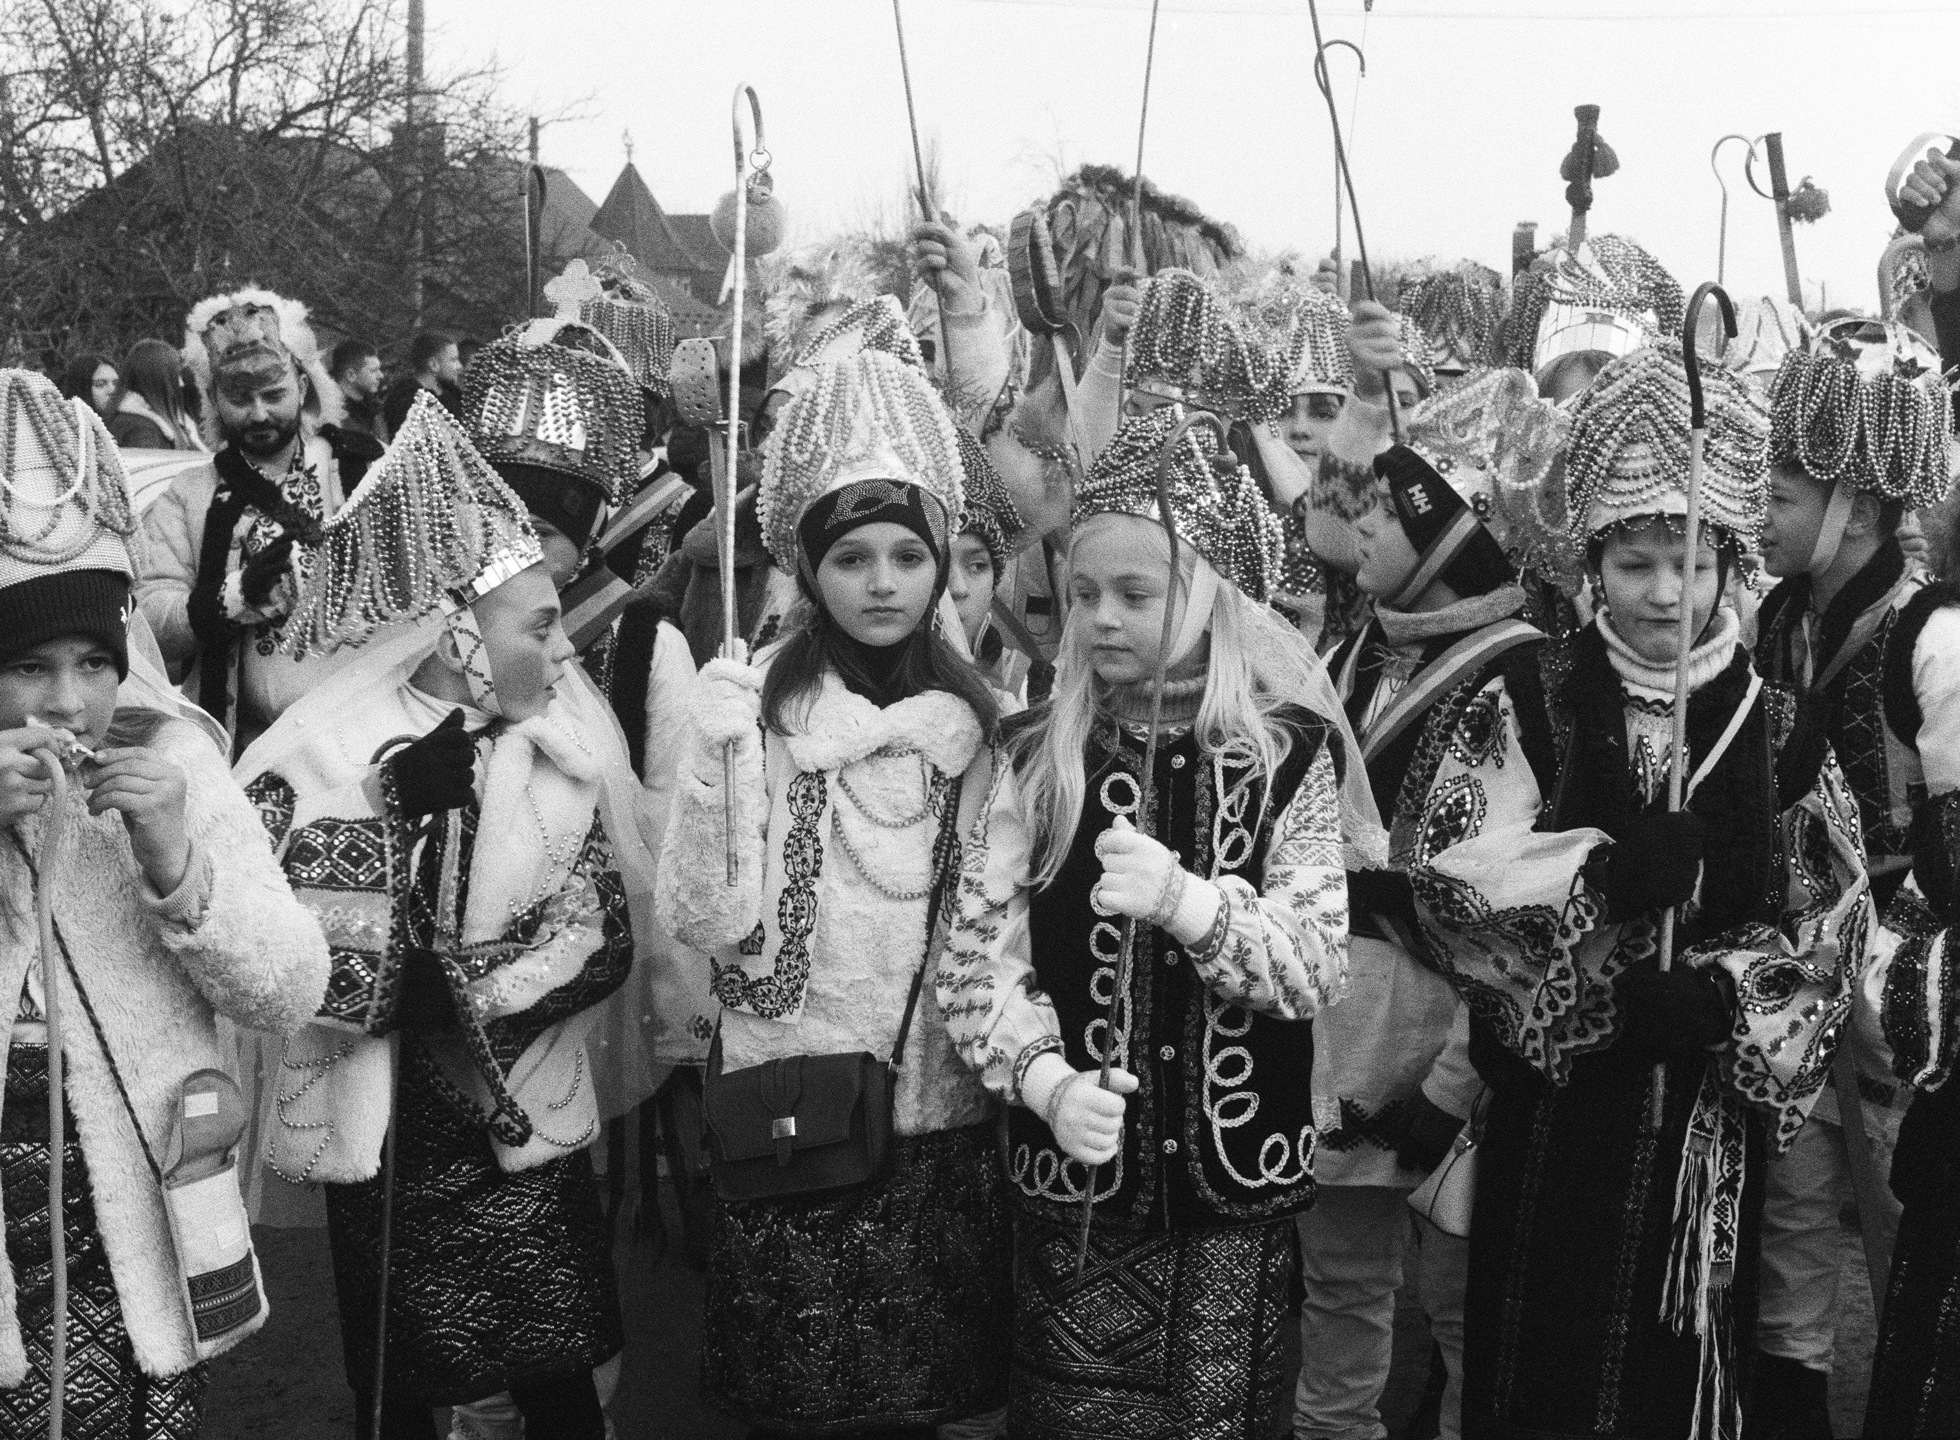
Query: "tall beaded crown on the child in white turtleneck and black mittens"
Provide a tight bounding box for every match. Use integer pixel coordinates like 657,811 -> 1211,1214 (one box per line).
1566,341 -> 1770,551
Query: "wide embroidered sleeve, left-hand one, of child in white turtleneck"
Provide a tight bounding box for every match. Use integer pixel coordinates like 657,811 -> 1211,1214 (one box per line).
1392,680 -> 1625,1085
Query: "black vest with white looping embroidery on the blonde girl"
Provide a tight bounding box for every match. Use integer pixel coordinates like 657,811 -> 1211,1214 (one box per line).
1007,709 -> 1341,1230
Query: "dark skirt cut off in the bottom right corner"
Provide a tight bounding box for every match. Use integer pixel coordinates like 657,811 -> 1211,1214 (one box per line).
1864,1191 -> 1960,1440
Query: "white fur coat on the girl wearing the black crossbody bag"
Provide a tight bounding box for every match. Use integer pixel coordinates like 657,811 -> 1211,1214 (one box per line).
655,674 -> 990,1134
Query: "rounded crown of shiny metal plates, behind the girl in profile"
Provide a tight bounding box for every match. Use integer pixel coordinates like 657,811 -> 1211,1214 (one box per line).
463,317 -> 647,504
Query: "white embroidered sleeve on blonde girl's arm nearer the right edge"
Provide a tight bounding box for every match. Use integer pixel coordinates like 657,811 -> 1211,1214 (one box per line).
1166,746 -> 1347,1021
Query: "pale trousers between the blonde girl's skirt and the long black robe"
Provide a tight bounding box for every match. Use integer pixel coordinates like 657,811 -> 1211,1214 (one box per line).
1294,1185 -> 1470,1440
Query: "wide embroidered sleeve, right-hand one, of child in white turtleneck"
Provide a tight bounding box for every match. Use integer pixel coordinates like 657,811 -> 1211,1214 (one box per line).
1709,756 -> 1874,1150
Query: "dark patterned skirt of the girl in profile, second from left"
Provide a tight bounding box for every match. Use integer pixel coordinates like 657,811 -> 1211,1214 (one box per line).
325,1042 -> 623,1405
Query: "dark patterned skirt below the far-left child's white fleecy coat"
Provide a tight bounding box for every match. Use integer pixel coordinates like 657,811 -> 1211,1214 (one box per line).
0,1044 -> 206,1440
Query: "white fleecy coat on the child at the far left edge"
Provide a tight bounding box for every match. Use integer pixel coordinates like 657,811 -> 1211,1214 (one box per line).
0,721 -> 327,1387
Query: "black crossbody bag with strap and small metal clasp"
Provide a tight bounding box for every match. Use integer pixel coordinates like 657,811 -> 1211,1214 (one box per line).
702,780 -> 960,1205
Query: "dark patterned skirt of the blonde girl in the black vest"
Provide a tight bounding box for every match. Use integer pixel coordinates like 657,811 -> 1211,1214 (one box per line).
1007,1213 -> 1298,1440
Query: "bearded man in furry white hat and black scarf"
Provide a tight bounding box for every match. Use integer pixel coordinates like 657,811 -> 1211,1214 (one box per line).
135,290 -> 380,750
